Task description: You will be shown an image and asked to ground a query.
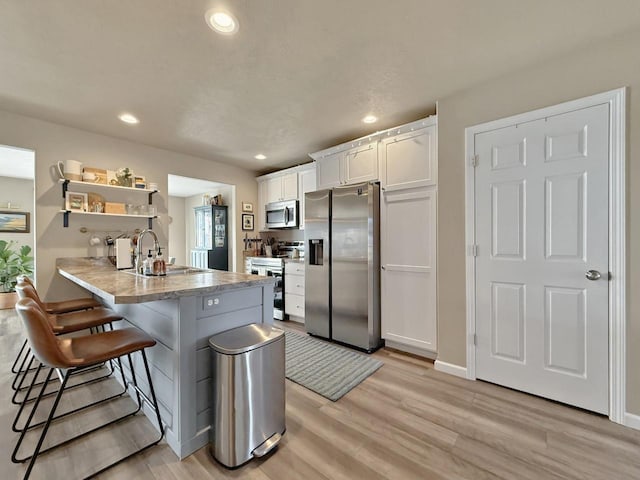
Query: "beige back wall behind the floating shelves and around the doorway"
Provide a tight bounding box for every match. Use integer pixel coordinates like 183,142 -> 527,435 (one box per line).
0,110 -> 258,300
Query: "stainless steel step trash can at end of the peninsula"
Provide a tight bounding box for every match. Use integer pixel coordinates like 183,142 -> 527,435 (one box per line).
209,324 -> 285,468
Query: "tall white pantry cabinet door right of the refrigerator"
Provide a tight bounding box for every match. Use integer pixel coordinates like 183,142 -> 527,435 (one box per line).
380,188 -> 437,352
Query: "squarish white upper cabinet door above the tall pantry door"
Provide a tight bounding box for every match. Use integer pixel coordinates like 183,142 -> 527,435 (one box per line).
380,125 -> 438,191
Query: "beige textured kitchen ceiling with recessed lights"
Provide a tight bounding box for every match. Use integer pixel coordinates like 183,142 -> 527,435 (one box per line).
0,0 -> 640,173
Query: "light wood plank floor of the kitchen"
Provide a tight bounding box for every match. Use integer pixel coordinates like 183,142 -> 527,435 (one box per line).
0,311 -> 640,480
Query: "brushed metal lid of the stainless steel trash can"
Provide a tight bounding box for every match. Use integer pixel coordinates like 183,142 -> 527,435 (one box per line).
209,323 -> 284,355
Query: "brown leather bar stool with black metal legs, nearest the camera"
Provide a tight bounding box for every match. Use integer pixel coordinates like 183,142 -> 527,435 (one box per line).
11,298 -> 164,480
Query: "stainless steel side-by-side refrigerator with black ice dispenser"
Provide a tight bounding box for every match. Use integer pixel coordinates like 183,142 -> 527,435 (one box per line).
304,183 -> 381,351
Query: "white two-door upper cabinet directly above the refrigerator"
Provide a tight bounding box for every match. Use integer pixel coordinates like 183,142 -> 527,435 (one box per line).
317,141 -> 378,189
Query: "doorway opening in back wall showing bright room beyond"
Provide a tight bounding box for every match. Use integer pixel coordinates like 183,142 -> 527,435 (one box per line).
167,175 -> 237,272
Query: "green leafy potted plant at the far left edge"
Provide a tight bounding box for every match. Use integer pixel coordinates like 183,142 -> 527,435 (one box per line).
0,240 -> 33,309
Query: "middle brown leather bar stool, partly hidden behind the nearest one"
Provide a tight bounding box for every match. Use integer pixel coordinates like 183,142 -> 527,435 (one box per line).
11,282 -> 123,406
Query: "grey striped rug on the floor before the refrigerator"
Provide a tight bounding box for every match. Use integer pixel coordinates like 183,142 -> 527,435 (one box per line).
285,331 -> 382,402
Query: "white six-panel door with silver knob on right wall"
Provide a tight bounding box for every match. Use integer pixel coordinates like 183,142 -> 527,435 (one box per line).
474,104 -> 609,413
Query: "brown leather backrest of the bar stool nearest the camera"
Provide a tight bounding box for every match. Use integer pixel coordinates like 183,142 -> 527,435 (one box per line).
16,298 -> 72,368
